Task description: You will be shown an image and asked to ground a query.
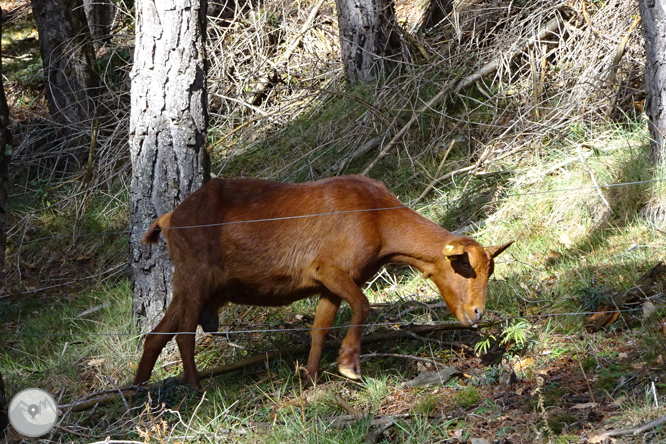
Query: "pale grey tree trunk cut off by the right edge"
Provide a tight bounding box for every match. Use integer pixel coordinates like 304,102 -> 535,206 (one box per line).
638,0 -> 666,164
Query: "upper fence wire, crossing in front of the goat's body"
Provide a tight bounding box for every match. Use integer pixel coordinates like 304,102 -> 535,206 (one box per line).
14,179 -> 666,246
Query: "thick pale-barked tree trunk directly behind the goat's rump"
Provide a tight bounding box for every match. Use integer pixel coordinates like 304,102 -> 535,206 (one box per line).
130,0 -> 210,328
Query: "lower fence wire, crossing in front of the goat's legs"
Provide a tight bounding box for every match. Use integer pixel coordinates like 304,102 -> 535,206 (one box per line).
0,301 -> 643,338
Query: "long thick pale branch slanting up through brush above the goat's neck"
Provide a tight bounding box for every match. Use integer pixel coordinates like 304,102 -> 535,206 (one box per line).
361,17 -> 560,175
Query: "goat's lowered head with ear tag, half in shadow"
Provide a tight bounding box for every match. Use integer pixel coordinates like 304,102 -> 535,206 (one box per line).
428,237 -> 513,324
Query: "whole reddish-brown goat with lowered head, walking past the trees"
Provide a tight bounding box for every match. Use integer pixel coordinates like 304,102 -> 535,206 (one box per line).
134,176 -> 511,386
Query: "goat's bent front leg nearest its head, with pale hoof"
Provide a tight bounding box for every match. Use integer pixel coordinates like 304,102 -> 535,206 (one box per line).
318,266 -> 370,379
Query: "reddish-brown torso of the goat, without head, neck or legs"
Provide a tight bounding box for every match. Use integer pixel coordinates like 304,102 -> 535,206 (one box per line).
165,176 -> 402,293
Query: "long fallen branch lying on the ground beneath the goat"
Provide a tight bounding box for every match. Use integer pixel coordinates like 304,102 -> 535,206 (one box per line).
58,321 -> 497,412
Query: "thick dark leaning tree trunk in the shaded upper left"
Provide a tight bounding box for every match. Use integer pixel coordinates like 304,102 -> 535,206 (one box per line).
32,0 -> 99,132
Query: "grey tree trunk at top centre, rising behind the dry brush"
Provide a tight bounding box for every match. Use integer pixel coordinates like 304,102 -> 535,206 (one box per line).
335,0 -> 395,84
